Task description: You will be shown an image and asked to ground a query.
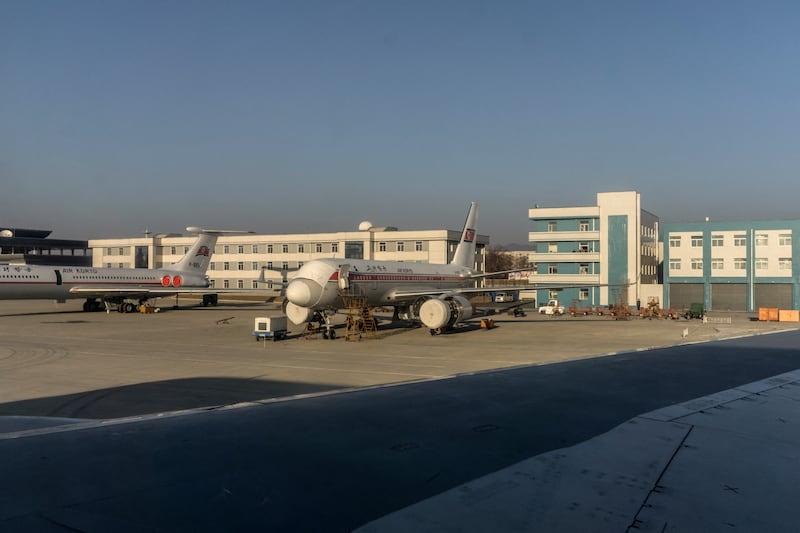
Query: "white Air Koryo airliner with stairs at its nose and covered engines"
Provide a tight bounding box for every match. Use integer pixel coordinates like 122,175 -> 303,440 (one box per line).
285,202 -> 506,338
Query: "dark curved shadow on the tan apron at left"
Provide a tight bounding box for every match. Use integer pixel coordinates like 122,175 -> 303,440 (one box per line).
0,377 -> 341,419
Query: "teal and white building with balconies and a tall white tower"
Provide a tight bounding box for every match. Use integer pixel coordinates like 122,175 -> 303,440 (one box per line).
528,191 -> 659,307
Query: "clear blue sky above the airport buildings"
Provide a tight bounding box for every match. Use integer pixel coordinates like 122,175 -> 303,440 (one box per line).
0,0 -> 800,244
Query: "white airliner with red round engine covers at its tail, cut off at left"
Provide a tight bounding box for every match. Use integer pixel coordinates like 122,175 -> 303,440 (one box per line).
0,227 -> 252,313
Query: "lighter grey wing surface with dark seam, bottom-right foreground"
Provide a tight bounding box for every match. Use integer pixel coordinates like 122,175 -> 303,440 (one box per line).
358,371 -> 800,533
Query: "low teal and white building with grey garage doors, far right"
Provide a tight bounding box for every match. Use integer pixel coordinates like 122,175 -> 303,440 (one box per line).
663,220 -> 800,312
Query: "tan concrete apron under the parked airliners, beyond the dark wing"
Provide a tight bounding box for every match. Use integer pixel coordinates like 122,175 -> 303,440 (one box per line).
0,299 -> 797,422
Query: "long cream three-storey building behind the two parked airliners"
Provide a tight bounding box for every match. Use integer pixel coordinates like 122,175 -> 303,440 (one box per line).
89,227 -> 489,289
